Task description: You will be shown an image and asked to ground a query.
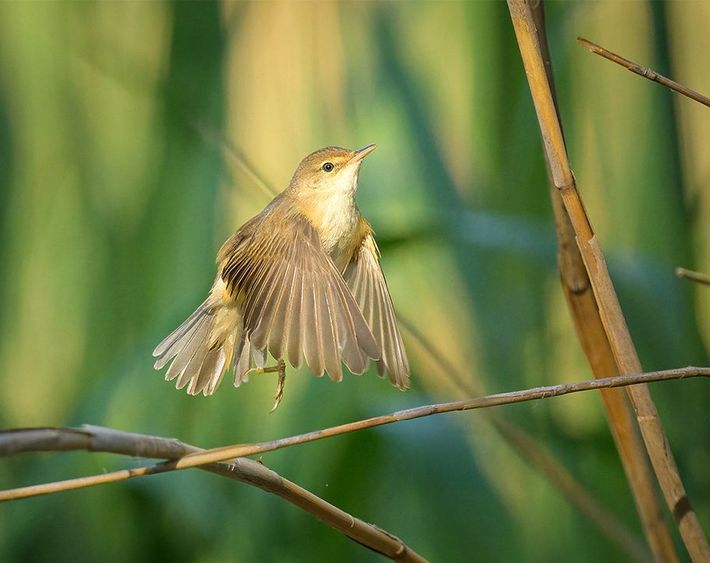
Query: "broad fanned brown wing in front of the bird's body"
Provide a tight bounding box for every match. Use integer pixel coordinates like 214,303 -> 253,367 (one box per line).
219,208 -> 380,381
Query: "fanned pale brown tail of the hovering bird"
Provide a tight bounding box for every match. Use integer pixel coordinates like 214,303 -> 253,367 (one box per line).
153,299 -> 265,396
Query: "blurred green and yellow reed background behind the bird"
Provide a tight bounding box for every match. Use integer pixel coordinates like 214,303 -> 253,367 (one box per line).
0,1 -> 710,562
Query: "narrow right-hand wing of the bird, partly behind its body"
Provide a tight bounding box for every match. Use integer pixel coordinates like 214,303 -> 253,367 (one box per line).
343,227 -> 409,389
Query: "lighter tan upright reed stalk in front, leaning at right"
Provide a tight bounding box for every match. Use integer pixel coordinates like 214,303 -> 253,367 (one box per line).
508,0 -> 710,561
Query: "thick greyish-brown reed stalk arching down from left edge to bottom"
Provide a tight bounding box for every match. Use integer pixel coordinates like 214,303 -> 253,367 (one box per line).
0,425 -> 426,563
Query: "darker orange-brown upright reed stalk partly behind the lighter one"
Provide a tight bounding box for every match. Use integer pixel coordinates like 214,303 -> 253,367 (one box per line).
532,2 -> 678,562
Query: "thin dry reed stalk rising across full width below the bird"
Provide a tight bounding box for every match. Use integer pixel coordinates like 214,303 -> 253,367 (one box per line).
0,366 -> 710,502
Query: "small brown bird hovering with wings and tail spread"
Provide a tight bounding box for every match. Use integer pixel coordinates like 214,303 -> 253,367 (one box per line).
153,145 -> 409,409
